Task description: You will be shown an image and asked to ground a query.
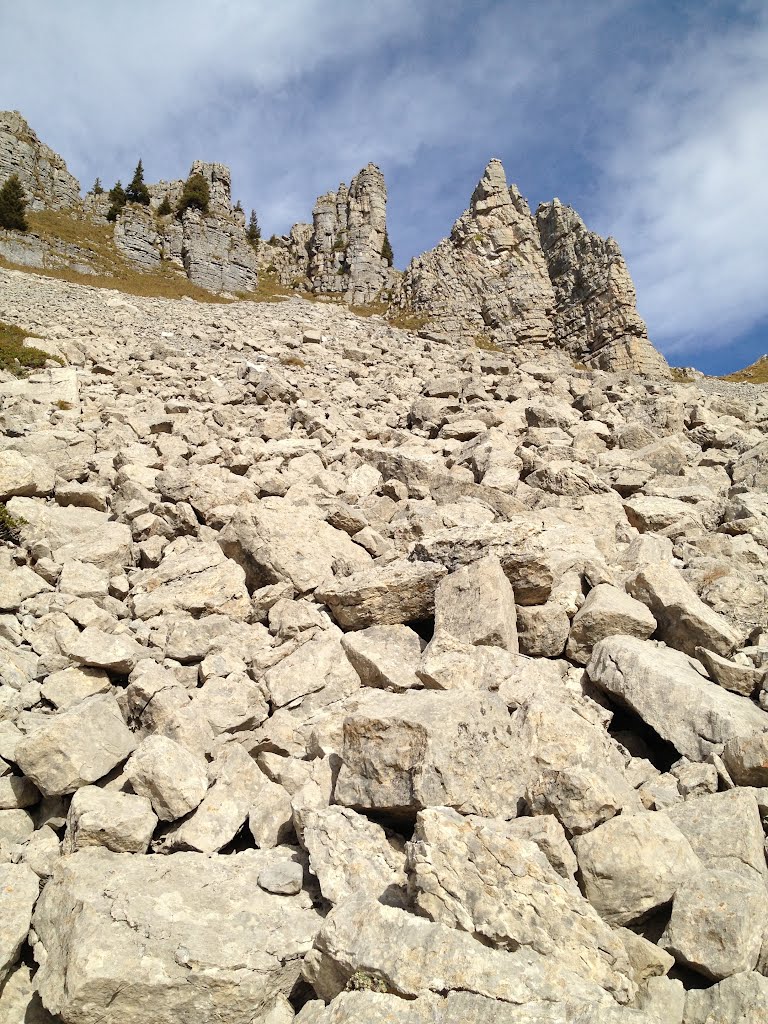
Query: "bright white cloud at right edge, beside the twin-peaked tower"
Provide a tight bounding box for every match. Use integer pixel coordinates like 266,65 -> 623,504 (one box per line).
596,7 -> 768,357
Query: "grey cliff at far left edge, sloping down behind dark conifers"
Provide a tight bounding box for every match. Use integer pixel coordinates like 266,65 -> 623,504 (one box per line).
0,111 -> 80,210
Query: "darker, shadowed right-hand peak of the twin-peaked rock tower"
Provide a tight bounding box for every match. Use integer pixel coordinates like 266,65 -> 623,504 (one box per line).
536,199 -> 669,376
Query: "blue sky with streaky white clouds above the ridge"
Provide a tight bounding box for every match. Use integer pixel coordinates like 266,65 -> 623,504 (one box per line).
0,0 -> 768,373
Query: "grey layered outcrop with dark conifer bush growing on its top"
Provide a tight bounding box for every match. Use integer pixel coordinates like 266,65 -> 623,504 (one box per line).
115,161 -> 257,292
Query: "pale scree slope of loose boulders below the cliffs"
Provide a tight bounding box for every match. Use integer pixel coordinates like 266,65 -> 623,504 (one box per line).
0,268 -> 768,1024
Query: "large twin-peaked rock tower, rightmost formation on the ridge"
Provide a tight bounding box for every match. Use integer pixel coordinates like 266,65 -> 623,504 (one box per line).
395,160 -> 669,375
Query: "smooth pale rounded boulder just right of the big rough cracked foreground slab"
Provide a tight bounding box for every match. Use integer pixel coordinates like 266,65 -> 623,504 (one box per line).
574,811 -> 701,925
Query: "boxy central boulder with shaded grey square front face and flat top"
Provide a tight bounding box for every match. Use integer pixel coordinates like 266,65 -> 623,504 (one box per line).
336,691 -> 524,817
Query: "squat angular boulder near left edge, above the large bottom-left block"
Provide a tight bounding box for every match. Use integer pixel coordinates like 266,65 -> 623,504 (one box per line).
15,694 -> 136,797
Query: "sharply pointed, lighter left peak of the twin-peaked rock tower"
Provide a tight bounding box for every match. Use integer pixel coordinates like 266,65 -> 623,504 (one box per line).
398,160 -> 555,343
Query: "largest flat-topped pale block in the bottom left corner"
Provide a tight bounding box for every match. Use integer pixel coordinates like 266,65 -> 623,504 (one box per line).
34,850 -> 321,1024
